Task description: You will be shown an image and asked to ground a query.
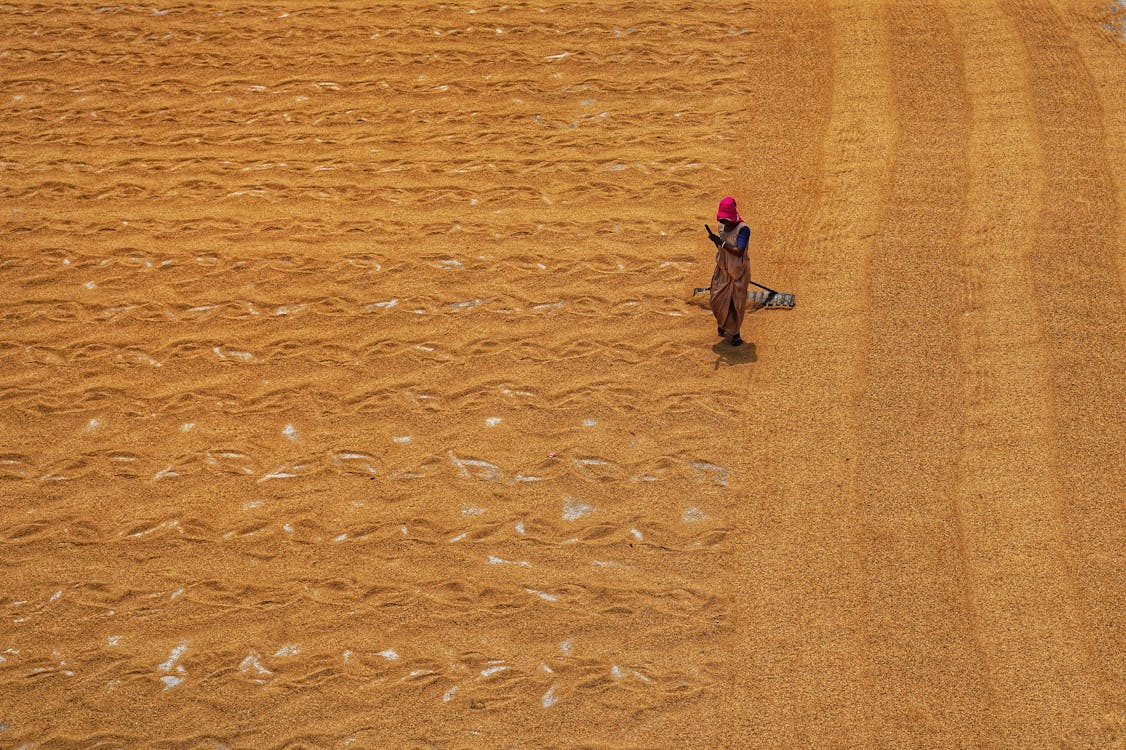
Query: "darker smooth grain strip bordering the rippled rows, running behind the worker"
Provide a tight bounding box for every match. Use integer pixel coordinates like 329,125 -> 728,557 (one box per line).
708,2 -> 837,747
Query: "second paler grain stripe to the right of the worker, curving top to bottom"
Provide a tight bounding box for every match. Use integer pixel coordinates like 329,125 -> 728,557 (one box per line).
957,3 -> 1097,747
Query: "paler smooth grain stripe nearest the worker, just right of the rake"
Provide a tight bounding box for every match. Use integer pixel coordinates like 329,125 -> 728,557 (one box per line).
729,2 -> 894,747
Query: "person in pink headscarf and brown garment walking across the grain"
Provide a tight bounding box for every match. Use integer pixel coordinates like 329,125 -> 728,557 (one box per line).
704,195 -> 751,347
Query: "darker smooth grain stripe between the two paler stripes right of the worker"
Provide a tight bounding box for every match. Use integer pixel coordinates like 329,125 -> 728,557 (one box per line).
857,3 -> 995,748
